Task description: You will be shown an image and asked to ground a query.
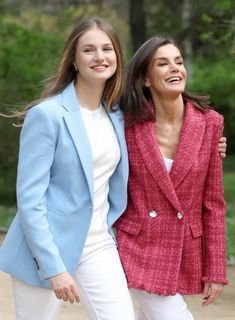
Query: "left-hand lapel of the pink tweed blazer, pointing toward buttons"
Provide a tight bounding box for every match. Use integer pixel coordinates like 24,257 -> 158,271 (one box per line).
134,121 -> 181,211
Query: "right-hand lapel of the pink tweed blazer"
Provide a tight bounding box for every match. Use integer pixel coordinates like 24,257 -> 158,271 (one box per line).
170,102 -> 205,189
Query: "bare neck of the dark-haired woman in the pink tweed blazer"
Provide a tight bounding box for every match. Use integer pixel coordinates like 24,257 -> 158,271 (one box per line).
153,95 -> 184,123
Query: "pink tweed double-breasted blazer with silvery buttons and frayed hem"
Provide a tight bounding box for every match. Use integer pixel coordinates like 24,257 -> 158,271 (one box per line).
115,103 -> 227,295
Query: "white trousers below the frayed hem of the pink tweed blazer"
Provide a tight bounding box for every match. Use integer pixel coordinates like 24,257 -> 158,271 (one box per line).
131,289 -> 194,320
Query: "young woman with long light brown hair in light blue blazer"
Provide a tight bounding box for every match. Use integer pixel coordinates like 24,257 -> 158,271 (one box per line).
0,18 -> 134,320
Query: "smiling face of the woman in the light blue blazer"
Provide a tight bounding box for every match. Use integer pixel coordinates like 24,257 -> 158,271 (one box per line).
74,27 -> 117,84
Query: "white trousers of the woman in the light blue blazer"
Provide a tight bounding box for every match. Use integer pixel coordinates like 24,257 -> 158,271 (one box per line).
12,239 -> 135,320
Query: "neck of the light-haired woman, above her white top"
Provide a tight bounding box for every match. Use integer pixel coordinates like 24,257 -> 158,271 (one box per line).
75,81 -> 104,110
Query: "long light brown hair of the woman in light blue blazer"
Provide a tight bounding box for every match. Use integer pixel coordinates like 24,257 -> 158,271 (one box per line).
1,17 -> 124,124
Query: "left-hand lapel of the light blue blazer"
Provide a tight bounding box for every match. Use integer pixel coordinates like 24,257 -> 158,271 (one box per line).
62,83 -> 94,200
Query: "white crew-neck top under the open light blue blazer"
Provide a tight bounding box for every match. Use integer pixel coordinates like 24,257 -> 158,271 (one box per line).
81,105 -> 120,246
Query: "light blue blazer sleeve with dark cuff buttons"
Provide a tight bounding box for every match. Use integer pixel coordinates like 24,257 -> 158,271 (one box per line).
16,107 -> 66,279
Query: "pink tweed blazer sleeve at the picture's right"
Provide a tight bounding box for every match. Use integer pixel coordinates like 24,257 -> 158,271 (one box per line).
202,115 -> 227,284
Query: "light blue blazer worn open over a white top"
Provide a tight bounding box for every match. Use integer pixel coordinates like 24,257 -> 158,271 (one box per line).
0,83 -> 128,287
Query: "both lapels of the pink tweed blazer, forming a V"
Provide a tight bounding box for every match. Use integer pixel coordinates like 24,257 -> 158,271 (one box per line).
134,103 -> 205,211
